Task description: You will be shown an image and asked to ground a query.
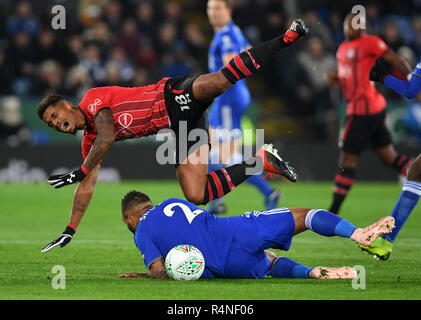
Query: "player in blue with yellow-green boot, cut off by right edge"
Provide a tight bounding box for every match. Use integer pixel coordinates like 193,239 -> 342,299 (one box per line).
360,61 -> 421,260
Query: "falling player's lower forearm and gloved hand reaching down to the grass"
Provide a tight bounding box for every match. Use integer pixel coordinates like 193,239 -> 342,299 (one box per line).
41,166 -> 100,252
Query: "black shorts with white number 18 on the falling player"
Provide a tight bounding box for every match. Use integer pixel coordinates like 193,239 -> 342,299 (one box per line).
164,75 -> 212,167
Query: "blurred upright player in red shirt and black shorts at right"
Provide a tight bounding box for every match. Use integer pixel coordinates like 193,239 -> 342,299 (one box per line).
326,14 -> 411,213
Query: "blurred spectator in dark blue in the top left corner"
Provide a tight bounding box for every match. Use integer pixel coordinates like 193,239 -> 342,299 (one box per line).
6,1 -> 39,38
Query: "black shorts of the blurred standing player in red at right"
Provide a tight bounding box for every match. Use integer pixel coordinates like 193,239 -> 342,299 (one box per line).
339,110 -> 392,155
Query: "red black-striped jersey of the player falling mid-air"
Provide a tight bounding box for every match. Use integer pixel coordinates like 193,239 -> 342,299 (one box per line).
79,78 -> 170,159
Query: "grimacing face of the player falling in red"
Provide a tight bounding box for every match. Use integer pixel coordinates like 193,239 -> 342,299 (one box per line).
42,101 -> 77,134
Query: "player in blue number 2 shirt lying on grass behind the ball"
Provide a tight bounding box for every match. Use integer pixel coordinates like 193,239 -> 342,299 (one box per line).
116,190 -> 394,279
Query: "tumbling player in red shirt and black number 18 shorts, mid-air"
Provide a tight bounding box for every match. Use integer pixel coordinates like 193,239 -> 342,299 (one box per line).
38,19 -> 308,252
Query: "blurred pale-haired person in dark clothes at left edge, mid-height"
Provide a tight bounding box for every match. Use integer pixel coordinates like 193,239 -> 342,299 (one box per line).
0,96 -> 29,147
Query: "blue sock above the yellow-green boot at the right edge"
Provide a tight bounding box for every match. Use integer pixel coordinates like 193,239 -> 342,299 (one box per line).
383,180 -> 421,242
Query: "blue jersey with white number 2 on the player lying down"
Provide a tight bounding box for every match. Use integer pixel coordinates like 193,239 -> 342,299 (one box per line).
134,198 -> 233,278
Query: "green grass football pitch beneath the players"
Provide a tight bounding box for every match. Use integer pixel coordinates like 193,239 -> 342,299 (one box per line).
0,181 -> 421,300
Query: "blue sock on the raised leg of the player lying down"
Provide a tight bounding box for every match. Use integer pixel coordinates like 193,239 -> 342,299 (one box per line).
305,209 -> 357,238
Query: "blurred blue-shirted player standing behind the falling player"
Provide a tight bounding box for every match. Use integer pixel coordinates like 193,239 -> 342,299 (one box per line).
207,0 -> 281,214
